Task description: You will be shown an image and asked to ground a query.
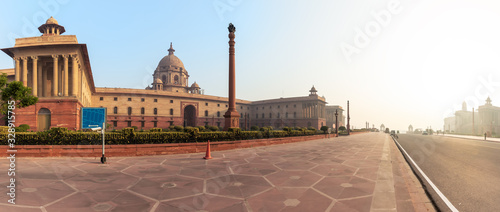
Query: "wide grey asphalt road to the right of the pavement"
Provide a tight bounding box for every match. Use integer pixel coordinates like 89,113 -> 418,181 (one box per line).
398,134 -> 500,211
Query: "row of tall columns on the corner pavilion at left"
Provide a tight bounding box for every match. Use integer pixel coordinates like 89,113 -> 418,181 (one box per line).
14,54 -> 80,96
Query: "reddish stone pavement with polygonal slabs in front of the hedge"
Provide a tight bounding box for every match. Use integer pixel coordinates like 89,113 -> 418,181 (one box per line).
0,133 -> 434,212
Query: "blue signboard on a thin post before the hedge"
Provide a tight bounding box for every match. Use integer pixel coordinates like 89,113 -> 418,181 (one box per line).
81,107 -> 106,163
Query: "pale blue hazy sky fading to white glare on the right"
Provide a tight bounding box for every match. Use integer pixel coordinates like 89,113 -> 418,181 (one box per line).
0,0 -> 500,131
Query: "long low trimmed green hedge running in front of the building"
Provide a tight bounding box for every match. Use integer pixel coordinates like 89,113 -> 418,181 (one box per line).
0,128 -> 316,145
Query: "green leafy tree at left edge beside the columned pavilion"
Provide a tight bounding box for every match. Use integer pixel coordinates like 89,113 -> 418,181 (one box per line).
0,73 -> 38,115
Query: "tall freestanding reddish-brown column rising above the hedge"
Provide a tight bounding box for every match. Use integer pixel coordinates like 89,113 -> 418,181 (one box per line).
224,24 -> 240,130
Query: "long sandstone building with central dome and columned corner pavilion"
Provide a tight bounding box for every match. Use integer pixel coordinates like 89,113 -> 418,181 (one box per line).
0,17 -> 343,131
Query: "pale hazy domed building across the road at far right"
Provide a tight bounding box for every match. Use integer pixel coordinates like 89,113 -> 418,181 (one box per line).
443,97 -> 500,136
